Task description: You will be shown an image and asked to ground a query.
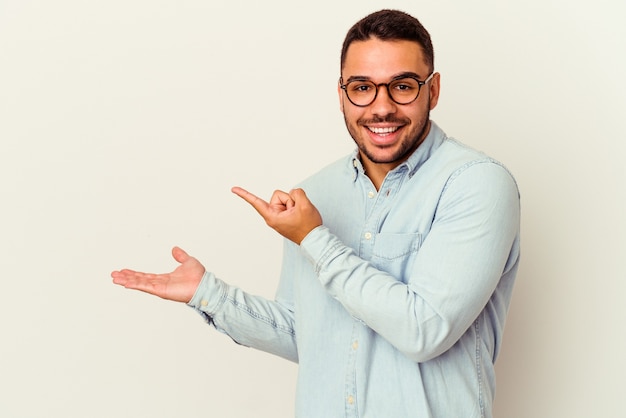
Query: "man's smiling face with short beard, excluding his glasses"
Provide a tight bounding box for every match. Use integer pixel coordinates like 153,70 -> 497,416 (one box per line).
338,38 -> 439,171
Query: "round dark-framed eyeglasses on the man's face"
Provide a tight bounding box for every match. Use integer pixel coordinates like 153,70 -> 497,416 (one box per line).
339,72 -> 435,107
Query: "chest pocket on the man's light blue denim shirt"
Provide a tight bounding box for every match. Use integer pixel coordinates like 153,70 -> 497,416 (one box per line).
370,233 -> 422,283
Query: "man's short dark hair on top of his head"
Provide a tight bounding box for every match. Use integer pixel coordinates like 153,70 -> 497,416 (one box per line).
341,9 -> 435,72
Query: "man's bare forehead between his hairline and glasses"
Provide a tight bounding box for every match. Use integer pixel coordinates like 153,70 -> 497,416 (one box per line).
342,38 -> 428,80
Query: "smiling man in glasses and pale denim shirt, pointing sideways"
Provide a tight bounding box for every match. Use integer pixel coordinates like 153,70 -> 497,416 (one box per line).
112,10 -> 520,418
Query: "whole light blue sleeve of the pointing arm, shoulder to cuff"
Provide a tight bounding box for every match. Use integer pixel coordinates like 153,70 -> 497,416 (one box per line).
301,163 -> 520,362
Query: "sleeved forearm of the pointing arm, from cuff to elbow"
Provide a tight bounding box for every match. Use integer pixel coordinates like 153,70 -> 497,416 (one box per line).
303,229 -> 454,361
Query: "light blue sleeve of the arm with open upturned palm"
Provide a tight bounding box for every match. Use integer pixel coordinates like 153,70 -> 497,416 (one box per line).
188,272 -> 298,362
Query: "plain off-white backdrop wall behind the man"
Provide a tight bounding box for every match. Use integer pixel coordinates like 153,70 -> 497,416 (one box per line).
0,0 -> 626,418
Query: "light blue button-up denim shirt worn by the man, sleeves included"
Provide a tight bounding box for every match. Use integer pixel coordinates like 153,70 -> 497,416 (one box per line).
189,122 -> 520,418
